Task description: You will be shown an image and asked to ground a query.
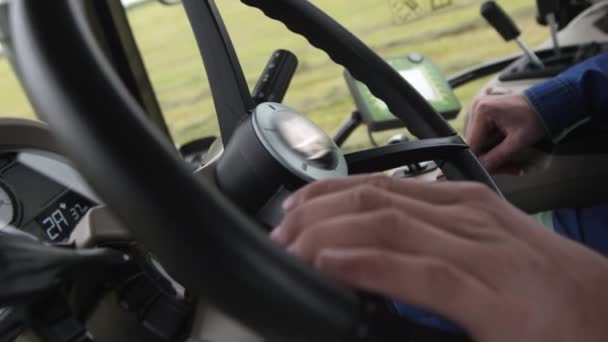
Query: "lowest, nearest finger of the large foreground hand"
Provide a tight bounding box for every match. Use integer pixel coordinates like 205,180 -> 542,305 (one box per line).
315,249 -> 492,331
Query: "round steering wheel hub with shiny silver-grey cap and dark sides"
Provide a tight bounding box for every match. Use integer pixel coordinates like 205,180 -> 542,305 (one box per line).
216,103 -> 348,213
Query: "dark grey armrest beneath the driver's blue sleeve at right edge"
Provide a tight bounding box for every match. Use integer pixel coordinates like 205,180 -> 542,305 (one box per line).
494,130 -> 608,213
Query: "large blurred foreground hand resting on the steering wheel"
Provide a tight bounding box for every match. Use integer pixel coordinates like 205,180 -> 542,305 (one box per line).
272,176 -> 608,342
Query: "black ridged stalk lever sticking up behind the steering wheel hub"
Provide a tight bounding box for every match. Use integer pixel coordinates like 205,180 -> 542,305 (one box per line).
252,50 -> 298,105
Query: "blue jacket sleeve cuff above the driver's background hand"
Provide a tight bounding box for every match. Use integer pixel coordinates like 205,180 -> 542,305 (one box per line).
524,54 -> 608,136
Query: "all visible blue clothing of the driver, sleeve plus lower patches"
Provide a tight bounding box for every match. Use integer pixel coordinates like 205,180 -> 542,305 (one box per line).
394,54 -> 608,332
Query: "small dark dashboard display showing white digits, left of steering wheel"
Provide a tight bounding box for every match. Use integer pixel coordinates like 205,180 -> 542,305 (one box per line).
35,191 -> 94,242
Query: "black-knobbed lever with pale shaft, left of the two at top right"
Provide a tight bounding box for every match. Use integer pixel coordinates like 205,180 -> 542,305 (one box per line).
481,0 -> 545,69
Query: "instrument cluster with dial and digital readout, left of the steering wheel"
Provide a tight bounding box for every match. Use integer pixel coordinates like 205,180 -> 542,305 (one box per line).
0,119 -> 99,243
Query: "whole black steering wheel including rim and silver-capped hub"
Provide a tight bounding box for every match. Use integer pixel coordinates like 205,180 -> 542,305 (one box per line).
10,0 -> 498,342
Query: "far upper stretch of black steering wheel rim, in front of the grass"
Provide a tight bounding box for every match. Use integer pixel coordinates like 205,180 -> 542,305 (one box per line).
236,0 -> 501,195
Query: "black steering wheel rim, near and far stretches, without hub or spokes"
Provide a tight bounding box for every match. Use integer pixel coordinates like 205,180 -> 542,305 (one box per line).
10,0 -> 497,341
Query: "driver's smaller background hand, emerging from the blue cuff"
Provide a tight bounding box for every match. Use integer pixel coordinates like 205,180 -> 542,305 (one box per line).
466,94 -> 545,172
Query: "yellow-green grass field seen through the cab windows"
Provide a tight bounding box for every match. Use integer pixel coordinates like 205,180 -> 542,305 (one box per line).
0,0 -> 548,150
